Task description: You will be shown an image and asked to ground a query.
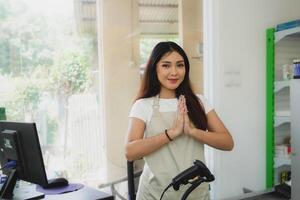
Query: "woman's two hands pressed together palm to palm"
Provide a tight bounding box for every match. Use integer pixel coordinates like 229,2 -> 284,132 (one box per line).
168,95 -> 196,139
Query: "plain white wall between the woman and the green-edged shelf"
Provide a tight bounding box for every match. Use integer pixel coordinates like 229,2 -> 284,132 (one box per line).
204,0 -> 300,199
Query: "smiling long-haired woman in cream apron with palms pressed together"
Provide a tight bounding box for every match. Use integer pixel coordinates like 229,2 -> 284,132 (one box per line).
126,42 -> 233,200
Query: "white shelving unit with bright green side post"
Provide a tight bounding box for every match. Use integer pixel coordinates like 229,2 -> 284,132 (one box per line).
266,25 -> 300,188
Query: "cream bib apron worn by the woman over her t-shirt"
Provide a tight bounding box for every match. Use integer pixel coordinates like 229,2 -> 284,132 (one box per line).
137,96 -> 210,200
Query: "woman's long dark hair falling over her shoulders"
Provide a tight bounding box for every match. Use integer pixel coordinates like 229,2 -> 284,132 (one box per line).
137,41 -> 207,130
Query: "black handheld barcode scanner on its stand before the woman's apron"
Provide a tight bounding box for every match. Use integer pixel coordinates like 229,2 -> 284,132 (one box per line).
160,160 -> 215,200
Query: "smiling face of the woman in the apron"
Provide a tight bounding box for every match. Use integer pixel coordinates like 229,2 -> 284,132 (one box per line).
156,51 -> 185,92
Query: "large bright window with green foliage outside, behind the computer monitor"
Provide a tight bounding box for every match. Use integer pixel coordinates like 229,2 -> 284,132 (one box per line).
0,0 -> 103,185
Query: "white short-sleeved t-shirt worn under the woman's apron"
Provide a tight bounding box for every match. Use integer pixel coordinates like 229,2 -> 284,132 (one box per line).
129,94 -> 213,125
